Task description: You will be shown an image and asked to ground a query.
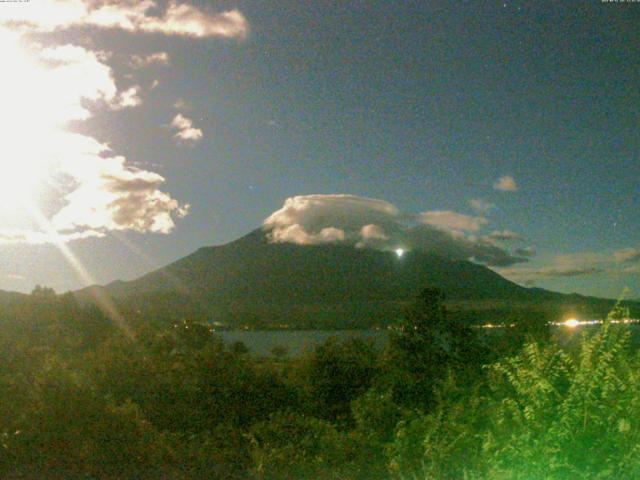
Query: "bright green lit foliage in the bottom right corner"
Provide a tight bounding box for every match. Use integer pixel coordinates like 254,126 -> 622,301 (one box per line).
390,300 -> 640,479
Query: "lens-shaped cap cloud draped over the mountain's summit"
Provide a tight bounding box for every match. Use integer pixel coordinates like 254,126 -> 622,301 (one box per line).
263,194 -> 528,266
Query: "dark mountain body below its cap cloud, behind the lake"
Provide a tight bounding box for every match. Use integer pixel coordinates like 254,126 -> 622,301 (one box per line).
76,230 -> 636,325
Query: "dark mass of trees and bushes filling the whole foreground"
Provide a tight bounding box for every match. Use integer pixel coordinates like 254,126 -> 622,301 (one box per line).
0,289 -> 640,480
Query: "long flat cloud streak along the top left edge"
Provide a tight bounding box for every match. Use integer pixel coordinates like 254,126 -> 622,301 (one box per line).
0,0 -> 249,39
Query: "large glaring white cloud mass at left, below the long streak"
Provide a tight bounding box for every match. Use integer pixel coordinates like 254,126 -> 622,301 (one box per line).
0,31 -> 187,243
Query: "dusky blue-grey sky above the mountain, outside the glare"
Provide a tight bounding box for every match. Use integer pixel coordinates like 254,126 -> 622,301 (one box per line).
0,0 -> 640,298
